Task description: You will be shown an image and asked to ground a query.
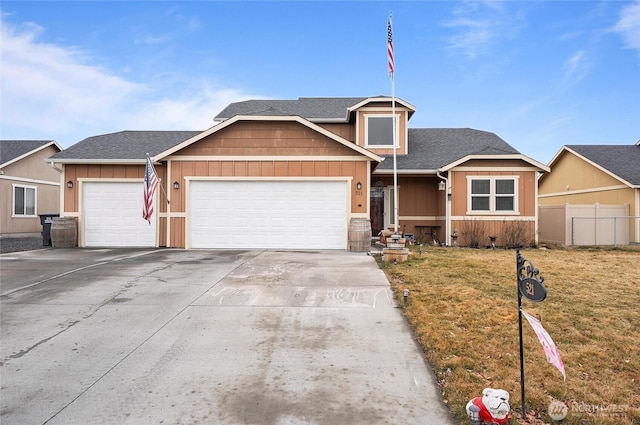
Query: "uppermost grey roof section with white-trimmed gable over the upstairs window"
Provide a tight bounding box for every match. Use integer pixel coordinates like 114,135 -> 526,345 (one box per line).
214,96 -> 415,122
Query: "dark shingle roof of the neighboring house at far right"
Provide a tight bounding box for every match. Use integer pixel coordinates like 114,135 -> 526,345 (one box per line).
567,145 -> 640,186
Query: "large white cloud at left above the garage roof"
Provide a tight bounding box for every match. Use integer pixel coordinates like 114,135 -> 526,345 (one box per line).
0,15 -> 259,147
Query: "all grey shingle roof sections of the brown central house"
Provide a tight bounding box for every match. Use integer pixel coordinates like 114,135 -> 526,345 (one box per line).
46,97 -> 519,170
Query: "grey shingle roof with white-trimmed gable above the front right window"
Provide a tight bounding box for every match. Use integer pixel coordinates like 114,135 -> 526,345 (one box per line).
376,128 -> 549,174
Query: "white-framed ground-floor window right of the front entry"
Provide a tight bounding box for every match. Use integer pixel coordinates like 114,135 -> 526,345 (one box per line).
469,177 -> 518,213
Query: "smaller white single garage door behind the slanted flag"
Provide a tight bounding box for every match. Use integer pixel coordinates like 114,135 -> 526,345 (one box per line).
82,182 -> 158,247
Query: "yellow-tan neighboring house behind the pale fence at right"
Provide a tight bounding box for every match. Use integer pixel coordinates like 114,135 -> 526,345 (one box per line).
539,141 -> 640,245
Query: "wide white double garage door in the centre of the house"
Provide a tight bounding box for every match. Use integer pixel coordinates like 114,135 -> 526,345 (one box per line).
189,181 -> 348,249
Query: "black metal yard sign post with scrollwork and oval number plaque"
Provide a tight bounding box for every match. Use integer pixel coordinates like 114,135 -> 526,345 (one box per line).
516,250 -> 547,419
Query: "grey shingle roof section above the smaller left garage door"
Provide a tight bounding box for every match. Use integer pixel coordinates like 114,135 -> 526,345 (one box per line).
52,131 -> 202,160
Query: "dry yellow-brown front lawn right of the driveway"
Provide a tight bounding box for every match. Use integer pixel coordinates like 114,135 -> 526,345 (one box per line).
382,247 -> 640,425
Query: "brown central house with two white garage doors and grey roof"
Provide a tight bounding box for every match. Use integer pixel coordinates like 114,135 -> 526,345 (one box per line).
50,96 -> 549,249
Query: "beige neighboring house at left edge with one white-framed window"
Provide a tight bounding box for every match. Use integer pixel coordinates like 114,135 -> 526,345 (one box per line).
0,140 -> 62,237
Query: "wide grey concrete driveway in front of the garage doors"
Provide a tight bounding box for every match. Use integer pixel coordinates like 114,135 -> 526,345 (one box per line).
0,249 -> 453,425
